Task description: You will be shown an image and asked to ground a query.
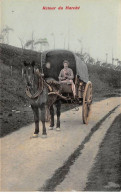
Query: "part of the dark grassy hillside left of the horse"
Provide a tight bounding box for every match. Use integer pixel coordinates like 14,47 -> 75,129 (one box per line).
0,44 -> 40,136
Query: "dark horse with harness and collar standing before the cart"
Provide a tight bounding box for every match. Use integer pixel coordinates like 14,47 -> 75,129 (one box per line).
24,61 -> 61,138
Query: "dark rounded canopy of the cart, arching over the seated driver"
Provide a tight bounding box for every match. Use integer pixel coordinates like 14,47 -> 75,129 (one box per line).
41,50 -> 89,83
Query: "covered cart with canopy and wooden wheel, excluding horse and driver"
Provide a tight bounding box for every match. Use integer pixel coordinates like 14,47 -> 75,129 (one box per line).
41,50 -> 92,124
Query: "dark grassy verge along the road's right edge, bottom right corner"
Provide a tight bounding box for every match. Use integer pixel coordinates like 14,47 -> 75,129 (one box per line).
85,114 -> 121,191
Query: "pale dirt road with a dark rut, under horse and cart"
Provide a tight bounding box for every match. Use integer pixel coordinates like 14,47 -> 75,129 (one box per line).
1,98 -> 121,191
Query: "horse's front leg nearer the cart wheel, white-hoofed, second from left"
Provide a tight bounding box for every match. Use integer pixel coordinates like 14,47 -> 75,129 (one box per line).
40,104 -> 47,138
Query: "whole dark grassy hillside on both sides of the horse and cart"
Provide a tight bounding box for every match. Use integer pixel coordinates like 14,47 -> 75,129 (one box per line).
0,44 -> 121,136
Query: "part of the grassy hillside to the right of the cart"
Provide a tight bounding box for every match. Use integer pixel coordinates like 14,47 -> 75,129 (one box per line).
87,65 -> 121,99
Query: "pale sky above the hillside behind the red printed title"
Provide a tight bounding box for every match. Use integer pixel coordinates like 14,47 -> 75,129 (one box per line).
0,0 -> 121,62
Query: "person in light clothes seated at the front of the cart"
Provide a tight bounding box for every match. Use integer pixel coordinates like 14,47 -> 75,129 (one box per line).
58,60 -> 75,97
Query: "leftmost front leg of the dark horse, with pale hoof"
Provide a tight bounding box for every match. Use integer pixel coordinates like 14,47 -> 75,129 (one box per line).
31,105 -> 39,137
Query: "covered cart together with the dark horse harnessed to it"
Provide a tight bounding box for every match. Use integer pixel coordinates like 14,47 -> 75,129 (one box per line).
24,50 -> 92,138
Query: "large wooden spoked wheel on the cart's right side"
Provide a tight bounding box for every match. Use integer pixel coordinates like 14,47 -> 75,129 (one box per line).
82,81 -> 92,124
